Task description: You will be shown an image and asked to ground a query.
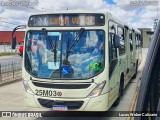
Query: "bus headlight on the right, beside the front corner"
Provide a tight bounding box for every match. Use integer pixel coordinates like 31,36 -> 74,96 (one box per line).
88,81 -> 106,97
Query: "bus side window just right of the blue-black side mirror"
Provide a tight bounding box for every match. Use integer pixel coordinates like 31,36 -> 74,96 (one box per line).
118,26 -> 125,56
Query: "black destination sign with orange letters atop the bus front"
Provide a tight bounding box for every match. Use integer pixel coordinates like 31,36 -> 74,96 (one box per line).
28,14 -> 105,27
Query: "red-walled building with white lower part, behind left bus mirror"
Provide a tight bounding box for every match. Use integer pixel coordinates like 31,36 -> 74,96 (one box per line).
0,31 -> 25,52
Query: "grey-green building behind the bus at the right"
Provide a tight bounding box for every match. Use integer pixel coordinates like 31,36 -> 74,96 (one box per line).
139,28 -> 152,48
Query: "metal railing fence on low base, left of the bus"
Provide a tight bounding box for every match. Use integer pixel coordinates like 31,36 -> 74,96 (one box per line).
0,61 -> 22,84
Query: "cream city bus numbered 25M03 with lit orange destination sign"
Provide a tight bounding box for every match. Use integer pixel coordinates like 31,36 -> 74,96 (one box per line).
13,10 -> 141,111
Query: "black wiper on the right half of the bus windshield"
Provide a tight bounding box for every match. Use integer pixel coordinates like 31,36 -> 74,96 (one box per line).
66,28 -> 85,60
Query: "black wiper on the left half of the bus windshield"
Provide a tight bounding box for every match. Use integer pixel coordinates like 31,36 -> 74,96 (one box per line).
42,28 -> 57,66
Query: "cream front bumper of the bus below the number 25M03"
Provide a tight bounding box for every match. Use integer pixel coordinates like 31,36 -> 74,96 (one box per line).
25,92 -> 109,111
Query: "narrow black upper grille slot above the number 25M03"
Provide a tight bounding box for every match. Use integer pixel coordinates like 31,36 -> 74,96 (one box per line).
32,82 -> 91,89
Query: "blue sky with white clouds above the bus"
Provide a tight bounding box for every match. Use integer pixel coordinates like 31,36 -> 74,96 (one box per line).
0,0 -> 160,31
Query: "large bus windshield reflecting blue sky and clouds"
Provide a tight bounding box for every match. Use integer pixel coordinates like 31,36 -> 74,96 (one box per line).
25,30 -> 104,79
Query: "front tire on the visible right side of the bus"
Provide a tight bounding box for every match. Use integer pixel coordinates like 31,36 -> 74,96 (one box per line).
113,75 -> 124,107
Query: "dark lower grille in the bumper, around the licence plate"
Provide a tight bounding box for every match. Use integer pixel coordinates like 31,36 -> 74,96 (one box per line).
38,98 -> 84,109
